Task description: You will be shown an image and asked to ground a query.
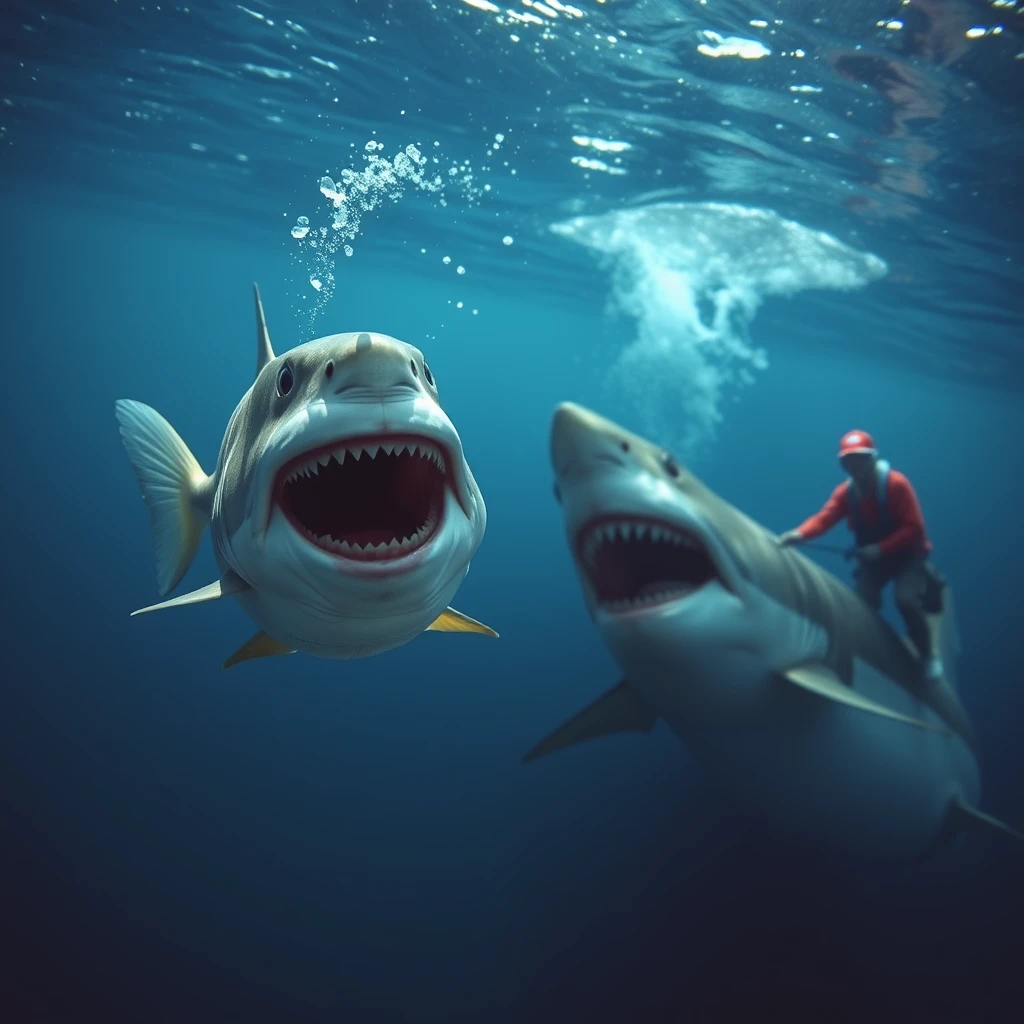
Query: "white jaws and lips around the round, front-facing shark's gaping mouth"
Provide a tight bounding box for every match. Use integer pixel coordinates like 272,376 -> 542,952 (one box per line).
251,389 -> 482,581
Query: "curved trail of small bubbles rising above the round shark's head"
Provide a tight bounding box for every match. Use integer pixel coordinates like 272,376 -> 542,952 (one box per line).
291,140 -> 481,331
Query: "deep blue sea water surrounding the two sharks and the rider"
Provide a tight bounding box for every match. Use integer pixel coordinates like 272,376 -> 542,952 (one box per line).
0,0 -> 1024,1024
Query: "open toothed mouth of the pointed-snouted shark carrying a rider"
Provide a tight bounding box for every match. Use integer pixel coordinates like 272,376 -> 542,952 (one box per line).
578,516 -> 721,611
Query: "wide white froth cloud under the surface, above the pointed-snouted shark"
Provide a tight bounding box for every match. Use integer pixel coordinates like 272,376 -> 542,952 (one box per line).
551,203 -> 888,458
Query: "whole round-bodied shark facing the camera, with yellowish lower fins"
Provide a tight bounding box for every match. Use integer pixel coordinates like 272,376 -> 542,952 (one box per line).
115,285 -> 498,669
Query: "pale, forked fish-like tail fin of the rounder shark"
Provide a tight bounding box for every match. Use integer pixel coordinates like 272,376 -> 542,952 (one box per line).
114,398 -> 210,597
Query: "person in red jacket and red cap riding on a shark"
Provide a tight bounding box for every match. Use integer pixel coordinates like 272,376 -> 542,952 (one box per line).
778,430 -> 942,681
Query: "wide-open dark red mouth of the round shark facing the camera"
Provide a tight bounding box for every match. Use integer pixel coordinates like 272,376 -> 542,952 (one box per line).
274,437 -> 445,561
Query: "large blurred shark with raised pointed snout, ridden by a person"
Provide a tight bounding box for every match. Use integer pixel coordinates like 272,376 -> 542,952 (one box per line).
522,402 -> 1024,859
